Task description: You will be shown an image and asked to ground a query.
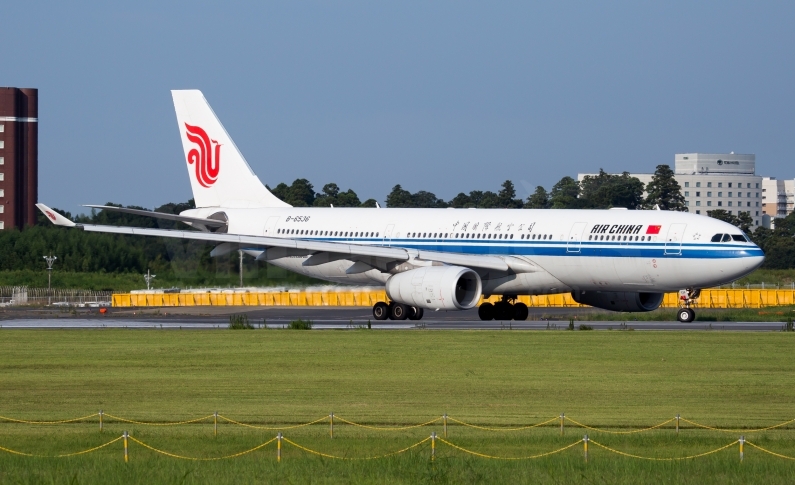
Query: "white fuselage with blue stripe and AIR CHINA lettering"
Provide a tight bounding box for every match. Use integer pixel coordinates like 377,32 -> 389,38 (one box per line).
183,207 -> 764,295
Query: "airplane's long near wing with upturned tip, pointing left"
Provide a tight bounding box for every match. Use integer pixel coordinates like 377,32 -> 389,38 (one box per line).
36,204 -> 509,271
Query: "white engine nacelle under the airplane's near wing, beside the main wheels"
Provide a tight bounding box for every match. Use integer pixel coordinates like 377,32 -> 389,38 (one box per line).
386,266 -> 483,310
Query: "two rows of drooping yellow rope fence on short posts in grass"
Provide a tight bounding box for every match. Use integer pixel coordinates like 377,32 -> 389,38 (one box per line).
0,411 -> 795,462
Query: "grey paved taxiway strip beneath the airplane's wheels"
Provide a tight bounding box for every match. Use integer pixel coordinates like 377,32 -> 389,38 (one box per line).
0,307 -> 784,331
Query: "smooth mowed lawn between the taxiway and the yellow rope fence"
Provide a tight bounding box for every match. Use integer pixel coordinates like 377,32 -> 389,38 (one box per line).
0,329 -> 795,426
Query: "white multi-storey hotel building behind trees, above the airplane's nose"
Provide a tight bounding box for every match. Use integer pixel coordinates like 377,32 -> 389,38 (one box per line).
577,153 -> 769,226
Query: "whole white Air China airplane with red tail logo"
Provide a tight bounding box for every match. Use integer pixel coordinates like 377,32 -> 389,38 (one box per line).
37,90 -> 764,322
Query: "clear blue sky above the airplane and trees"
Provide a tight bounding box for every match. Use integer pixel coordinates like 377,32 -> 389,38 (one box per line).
0,1 -> 795,212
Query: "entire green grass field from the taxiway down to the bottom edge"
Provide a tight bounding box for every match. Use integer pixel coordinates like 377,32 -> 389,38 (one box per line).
0,330 -> 795,483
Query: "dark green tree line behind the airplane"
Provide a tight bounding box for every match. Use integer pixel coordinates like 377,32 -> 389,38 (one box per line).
0,165 -> 795,286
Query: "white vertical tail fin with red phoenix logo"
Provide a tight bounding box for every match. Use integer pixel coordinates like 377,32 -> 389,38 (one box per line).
171,89 -> 290,207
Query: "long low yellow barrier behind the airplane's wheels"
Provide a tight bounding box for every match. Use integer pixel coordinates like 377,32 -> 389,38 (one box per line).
111,289 -> 795,308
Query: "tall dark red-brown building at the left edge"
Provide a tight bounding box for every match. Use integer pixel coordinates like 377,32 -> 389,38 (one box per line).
0,87 -> 39,230
